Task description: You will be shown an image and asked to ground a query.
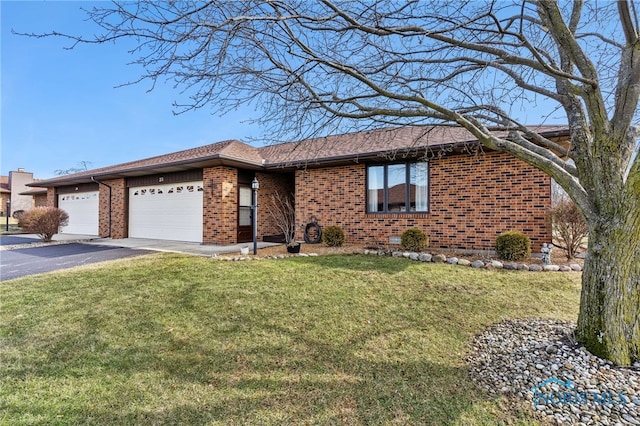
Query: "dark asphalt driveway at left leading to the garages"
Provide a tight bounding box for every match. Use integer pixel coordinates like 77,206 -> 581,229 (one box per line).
0,241 -> 151,281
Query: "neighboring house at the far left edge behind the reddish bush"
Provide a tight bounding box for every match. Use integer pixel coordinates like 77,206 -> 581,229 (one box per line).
0,168 -> 47,216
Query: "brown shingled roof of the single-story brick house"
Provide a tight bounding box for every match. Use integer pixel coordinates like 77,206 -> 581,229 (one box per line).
33,126 -> 568,187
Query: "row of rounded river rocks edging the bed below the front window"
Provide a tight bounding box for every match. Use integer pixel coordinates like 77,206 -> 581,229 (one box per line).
364,250 -> 582,272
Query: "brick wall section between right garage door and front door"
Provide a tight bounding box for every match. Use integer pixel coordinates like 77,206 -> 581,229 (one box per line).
202,166 -> 238,244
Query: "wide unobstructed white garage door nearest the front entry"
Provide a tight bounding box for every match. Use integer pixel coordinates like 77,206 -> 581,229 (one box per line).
129,181 -> 202,243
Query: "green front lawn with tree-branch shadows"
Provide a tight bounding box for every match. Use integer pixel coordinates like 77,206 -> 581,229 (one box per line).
0,254 -> 580,425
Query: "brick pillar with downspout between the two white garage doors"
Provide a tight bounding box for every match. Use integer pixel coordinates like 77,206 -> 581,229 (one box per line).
98,178 -> 129,239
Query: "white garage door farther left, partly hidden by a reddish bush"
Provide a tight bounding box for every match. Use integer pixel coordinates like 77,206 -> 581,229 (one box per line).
58,191 -> 99,235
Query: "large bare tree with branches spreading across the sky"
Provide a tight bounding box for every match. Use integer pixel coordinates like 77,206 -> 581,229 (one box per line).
23,0 -> 640,365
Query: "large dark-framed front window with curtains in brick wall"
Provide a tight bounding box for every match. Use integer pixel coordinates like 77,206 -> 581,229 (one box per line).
367,162 -> 429,213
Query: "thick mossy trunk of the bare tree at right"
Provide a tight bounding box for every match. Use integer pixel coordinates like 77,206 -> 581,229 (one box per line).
577,195 -> 640,366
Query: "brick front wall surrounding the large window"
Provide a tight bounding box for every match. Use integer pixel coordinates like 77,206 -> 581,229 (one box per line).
295,152 -> 551,252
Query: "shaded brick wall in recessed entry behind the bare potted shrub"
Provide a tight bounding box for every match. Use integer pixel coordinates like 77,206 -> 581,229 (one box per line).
256,172 -> 302,241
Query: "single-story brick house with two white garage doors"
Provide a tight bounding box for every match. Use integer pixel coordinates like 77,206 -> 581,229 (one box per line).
31,126 -> 569,250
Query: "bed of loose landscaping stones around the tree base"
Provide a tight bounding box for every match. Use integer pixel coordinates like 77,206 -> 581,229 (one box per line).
467,319 -> 640,426
